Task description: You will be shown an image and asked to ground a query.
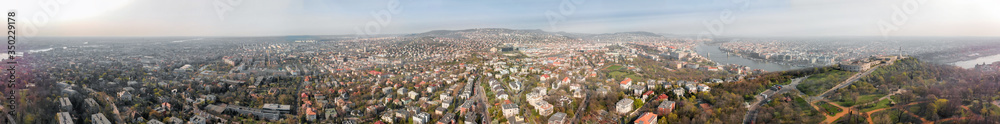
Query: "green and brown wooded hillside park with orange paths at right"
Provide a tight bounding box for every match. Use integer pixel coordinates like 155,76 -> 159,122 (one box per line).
756,58 -> 1000,123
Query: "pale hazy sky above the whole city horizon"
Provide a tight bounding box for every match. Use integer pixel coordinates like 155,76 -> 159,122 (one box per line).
0,0 -> 1000,37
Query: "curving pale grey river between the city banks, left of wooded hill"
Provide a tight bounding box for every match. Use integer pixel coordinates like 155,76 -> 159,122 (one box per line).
695,43 -> 803,72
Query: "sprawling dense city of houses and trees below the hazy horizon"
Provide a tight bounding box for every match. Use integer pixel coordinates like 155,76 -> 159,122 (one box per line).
3,28 -> 1000,123
